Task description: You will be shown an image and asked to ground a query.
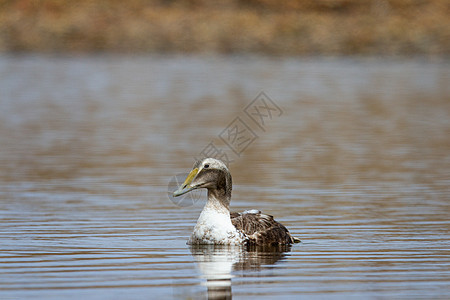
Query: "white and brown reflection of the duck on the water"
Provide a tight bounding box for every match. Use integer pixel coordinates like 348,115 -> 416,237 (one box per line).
190,245 -> 291,299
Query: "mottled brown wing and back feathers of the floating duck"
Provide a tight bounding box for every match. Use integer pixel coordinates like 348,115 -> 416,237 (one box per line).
230,212 -> 298,246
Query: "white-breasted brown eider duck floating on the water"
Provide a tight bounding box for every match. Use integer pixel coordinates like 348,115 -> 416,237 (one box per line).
173,158 -> 300,246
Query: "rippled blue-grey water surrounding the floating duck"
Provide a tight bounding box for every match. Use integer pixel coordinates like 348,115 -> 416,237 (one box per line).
0,56 -> 450,299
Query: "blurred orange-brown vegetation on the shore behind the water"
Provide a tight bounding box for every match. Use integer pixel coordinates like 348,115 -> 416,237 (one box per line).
0,0 -> 450,56
